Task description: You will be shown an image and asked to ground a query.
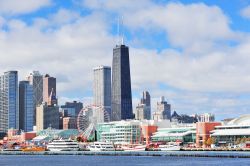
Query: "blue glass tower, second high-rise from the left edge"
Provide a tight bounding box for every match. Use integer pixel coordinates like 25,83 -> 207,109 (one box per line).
19,81 -> 34,131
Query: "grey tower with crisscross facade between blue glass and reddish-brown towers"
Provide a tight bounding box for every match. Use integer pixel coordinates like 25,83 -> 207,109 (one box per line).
27,71 -> 43,125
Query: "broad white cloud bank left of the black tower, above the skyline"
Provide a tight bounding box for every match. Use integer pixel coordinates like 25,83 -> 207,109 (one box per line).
0,11 -> 114,94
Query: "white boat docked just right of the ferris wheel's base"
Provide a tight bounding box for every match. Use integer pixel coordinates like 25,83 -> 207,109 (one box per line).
89,142 -> 115,151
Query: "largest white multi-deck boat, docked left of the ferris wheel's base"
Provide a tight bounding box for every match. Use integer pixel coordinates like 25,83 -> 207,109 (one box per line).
47,140 -> 79,151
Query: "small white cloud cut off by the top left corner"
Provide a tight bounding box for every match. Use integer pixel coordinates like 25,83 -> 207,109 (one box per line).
0,0 -> 51,15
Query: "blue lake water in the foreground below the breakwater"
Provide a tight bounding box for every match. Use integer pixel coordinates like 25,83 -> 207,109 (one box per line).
0,155 -> 250,166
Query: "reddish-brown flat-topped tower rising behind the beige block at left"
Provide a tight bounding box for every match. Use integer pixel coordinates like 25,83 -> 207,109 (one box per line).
43,74 -> 57,105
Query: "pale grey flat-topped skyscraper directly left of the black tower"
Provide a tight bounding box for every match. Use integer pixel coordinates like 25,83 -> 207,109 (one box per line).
93,66 -> 111,116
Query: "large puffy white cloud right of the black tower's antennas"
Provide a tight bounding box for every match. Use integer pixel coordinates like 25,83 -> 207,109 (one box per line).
123,3 -> 235,54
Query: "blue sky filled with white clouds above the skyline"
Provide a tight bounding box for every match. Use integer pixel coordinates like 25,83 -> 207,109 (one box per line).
0,0 -> 250,120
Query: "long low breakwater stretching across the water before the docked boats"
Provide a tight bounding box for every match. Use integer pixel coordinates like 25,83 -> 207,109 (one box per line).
0,151 -> 250,158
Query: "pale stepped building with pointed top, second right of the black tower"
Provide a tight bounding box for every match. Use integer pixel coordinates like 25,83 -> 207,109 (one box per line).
153,96 -> 171,120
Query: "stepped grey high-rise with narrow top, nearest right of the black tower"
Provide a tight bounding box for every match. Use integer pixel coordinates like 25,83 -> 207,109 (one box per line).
135,91 -> 151,120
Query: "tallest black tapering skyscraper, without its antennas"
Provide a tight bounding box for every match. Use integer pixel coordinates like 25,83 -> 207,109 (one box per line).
112,44 -> 133,121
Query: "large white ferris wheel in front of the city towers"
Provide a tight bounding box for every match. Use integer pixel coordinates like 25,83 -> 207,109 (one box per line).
77,105 -> 110,138
